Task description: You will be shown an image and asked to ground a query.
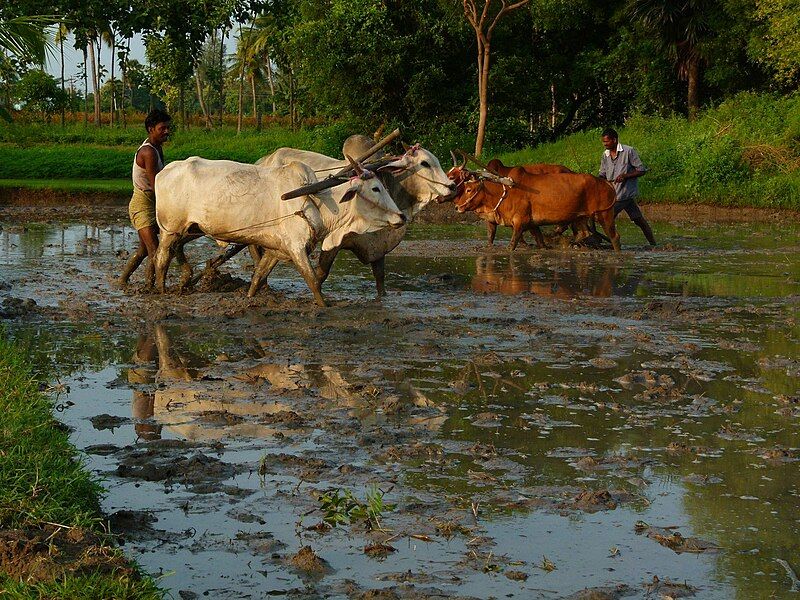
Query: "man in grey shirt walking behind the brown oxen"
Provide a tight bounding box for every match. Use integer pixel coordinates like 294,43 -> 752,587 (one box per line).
600,128 -> 656,246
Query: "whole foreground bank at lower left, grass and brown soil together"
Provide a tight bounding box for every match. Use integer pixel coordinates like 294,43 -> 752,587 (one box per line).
0,332 -> 163,599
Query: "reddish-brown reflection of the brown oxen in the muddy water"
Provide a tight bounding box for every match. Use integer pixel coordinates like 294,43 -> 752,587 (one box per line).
472,256 -> 617,300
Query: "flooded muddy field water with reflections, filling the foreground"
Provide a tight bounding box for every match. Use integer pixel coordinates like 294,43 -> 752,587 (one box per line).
0,218 -> 800,599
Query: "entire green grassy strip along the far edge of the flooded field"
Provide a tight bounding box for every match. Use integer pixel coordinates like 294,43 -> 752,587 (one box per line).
0,94 -> 800,210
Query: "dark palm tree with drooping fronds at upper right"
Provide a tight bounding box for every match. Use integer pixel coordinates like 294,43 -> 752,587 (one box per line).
630,0 -> 717,121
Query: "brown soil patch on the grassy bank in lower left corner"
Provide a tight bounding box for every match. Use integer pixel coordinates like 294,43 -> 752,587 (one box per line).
0,525 -> 139,584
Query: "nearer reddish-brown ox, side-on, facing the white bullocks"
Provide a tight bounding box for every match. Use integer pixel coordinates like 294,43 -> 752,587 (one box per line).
455,167 -> 620,250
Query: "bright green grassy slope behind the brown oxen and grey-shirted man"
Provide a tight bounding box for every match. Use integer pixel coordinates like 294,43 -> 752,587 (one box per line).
501,94 -> 800,210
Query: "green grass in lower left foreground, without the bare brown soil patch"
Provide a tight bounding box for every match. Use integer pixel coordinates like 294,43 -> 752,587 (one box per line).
0,331 -> 162,598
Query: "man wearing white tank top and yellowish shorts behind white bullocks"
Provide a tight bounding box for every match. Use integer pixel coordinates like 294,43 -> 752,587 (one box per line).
119,109 -> 172,286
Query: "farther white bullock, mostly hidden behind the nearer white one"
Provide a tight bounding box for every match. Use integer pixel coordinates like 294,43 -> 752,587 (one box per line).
256,144 -> 456,296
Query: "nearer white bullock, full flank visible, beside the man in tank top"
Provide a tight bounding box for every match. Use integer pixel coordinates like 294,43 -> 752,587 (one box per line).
155,156 -> 406,306
